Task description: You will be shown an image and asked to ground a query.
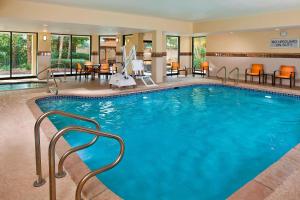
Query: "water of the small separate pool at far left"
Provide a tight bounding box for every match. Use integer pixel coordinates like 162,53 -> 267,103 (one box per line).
0,82 -> 46,91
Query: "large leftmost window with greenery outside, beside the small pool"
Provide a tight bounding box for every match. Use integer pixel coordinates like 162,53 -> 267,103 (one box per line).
0,32 -> 37,78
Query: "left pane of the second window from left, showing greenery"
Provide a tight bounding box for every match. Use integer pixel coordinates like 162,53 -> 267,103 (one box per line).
51,34 -> 71,74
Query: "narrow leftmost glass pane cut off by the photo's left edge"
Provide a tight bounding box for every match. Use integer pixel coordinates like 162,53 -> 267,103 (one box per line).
0,32 -> 11,78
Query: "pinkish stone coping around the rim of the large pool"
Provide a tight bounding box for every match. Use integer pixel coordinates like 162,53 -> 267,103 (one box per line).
27,82 -> 300,200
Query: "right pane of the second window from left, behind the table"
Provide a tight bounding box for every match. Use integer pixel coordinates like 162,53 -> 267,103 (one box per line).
71,35 -> 91,73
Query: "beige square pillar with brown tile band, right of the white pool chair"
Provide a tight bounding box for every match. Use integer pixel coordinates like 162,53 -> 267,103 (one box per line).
151,30 -> 167,83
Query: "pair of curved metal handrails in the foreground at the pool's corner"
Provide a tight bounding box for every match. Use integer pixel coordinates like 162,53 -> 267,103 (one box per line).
33,110 -> 125,200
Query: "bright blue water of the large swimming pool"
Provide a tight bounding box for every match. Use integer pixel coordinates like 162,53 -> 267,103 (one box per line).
37,85 -> 300,200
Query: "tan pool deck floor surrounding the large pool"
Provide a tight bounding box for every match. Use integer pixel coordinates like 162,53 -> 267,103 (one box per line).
0,77 -> 300,200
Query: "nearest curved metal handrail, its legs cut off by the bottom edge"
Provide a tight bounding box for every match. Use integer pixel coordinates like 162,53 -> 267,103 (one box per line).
48,126 -> 125,200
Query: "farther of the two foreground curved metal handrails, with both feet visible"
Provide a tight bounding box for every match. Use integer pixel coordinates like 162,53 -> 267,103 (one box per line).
33,110 -> 100,187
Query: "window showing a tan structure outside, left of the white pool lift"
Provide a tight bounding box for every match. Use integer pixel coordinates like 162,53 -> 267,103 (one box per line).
99,36 -> 117,64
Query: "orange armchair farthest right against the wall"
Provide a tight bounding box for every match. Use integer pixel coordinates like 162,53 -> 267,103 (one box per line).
274,65 -> 296,88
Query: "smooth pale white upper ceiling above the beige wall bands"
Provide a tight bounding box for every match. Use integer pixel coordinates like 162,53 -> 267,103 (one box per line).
17,0 -> 300,21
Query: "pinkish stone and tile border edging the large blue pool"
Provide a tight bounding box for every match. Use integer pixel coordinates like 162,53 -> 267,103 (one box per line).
28,83 -> 300,200
